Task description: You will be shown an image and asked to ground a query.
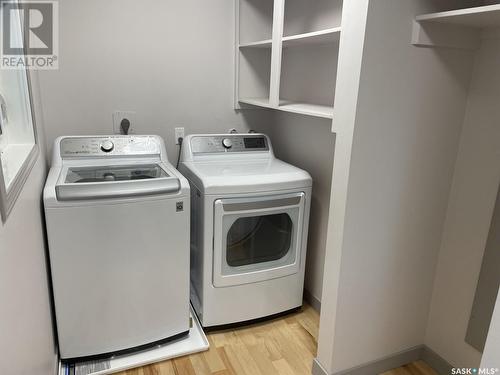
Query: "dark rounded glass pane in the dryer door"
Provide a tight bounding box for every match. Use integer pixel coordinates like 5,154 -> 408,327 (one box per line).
226,213 -> 293,267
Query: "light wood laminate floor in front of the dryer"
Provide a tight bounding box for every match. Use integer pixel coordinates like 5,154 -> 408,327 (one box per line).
119,305 -> 437,375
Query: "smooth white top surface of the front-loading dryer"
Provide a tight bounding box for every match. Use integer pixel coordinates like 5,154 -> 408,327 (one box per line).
181,159 -> 312,194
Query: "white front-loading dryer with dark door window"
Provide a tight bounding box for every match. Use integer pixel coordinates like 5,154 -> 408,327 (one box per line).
179,133 -> 312,327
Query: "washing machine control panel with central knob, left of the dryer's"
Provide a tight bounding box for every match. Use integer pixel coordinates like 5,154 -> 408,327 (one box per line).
60,136 -> 161,158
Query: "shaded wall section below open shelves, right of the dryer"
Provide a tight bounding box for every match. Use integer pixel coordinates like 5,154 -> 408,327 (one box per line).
257,112 -> 335,301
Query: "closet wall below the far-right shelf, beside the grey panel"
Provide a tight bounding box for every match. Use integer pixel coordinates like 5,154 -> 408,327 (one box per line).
426,33 -> 500,367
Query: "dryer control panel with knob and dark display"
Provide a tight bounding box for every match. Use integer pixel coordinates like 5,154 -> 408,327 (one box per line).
191,134 -> 269,154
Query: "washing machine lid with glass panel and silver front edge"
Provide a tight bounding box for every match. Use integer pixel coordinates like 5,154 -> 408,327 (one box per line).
55,164 -> 181,201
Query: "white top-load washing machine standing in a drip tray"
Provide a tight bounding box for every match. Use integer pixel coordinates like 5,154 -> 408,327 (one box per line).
44,136 -> 189,362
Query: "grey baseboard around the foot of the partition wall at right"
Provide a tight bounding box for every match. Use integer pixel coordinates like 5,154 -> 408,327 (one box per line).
312,345 -> 453,375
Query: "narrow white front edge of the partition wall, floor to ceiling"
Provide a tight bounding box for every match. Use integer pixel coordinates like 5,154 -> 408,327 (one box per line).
313,0 -> 369,373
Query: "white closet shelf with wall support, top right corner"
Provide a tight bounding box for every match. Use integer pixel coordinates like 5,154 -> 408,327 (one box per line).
412,4 -> 500,50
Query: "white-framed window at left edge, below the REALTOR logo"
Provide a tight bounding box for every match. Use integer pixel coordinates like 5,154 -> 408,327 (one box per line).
0,3 -> 38,221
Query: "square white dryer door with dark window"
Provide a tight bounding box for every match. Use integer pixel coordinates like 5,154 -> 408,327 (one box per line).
213,192 -> 305,287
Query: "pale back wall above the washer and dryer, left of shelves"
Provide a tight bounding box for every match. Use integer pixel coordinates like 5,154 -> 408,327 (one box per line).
40,0 -> 269,161
